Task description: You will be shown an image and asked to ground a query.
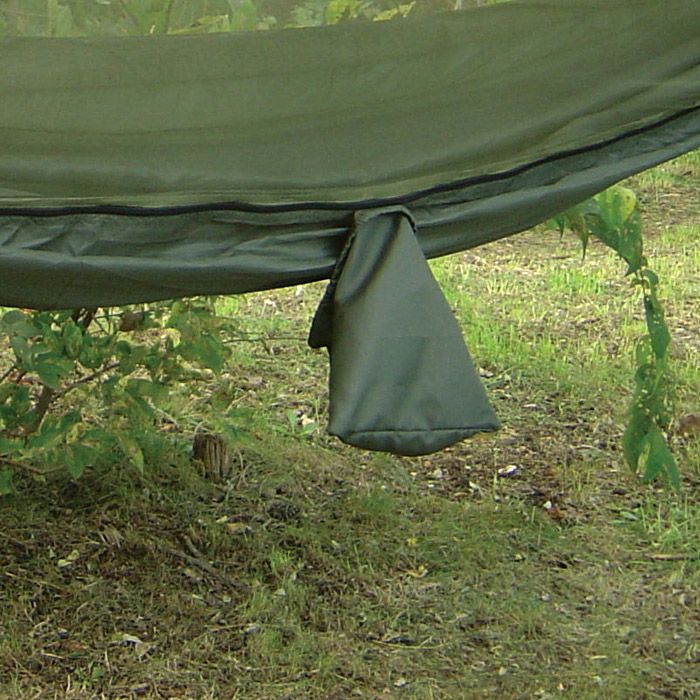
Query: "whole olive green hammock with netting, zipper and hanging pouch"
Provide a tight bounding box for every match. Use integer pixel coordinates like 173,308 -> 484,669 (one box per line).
0,0 -> 700,454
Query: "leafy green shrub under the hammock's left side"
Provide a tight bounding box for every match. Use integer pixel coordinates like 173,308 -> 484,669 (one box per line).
0,299 -> 234,494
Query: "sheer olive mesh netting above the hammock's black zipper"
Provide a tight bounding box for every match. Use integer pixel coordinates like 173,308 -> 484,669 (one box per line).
0,0 -> 700,208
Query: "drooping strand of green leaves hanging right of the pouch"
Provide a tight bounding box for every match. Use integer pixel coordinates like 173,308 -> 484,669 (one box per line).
550,185 -> 679,490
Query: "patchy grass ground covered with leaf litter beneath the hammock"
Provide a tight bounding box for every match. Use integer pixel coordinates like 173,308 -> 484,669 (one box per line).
0,154 -> 700,700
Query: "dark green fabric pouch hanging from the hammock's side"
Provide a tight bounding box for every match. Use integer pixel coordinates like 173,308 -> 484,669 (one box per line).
309,207 -> 499,456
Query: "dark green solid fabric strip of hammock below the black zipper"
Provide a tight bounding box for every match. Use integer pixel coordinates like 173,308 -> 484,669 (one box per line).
0,109 -> 700,309
